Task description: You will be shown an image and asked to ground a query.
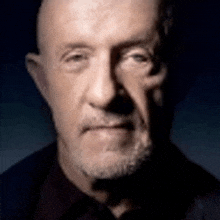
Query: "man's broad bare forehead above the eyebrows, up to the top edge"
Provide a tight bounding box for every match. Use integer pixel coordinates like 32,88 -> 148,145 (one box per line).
38,0 -> 160,52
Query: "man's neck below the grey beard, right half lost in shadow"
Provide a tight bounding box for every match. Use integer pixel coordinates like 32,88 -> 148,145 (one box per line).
58,138 -> 174,218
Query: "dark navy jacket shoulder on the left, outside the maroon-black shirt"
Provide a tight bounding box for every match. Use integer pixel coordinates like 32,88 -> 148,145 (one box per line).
0,143 -> 56,219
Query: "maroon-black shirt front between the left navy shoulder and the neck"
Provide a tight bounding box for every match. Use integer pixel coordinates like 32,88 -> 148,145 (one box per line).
34,161 -> 115,220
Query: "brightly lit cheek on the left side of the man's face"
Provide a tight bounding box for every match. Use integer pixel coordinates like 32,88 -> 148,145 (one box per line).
45,72 -> 83,133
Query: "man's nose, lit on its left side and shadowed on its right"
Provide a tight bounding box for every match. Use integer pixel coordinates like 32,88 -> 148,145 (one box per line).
87,56 -> 118,108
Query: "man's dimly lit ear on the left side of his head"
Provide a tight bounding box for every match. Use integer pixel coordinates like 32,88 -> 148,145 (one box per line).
25,53 -> 49,103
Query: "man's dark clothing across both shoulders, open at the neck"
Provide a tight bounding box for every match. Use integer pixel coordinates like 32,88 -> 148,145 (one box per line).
0,143 -> 220,220
